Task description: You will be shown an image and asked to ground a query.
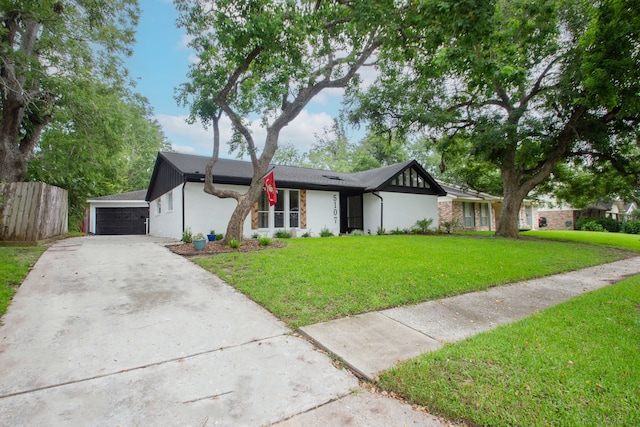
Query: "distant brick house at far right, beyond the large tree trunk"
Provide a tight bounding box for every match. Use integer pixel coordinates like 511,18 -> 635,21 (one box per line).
538,199 -> 636,230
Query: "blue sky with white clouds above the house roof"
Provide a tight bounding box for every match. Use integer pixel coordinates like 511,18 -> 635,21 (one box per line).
127,0 -> 361,157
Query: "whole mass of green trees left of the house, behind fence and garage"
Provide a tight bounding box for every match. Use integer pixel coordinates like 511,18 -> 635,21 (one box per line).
0,0 -> 169,229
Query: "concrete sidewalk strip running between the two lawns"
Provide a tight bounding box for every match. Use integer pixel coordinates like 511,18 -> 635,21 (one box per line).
301,257 -> 640,381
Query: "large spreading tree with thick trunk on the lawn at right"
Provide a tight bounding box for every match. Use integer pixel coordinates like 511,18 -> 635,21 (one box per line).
352,0 -> 640,237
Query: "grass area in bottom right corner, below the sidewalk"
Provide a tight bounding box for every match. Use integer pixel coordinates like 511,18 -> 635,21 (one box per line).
381,276 -> 640,426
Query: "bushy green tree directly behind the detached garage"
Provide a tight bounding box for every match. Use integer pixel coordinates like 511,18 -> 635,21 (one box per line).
27,80 -> 170,229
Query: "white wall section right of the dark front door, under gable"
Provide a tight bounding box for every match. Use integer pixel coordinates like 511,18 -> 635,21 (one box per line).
363,192 -> 438,234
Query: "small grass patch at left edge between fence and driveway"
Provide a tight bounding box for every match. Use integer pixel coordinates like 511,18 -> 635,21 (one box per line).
0,246 -> 46,316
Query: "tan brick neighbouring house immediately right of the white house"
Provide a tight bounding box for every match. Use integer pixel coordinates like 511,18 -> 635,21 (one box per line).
438,181 -> 538,231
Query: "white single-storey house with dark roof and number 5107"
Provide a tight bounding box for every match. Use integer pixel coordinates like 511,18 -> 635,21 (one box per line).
145,152 -> 445,239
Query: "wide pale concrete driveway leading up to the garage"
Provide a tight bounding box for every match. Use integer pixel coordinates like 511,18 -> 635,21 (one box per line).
0,236 -> 447,427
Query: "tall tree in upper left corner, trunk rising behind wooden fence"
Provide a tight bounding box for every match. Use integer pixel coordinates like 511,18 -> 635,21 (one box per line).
0,0 -> 139,181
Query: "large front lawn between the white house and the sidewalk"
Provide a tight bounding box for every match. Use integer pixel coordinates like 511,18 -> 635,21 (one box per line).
196,235 -> 628,327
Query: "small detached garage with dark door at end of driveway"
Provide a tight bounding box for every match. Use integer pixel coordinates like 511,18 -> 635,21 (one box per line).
85,190 -> 149,234
